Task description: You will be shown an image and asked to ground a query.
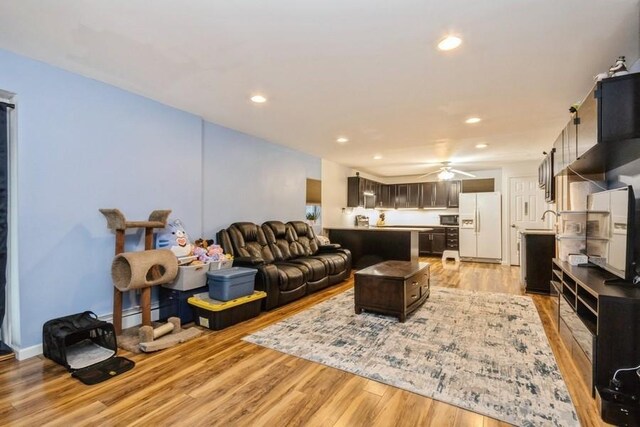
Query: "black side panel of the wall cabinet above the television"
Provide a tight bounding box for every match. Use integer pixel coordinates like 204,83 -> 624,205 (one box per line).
596,73 -> 640,142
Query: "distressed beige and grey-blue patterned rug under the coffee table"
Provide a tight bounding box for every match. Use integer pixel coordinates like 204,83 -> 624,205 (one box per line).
244,287 -> 579,426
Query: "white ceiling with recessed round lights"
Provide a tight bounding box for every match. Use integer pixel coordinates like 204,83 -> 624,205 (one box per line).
0,0 -> 640,177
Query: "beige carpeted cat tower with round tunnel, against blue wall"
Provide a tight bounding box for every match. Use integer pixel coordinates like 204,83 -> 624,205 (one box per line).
100,209 -> 202,352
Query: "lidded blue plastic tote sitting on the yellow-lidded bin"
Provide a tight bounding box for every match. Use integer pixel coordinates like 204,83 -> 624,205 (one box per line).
207,267 -> 258,301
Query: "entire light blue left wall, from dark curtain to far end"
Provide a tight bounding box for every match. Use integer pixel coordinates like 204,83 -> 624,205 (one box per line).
0,50 -> 321,348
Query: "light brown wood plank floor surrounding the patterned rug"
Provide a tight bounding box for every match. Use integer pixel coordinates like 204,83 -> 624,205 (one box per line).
0,258 -> 601,427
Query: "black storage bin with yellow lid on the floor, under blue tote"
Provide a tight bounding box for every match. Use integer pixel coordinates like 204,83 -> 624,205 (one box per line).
188,291 -> 267,331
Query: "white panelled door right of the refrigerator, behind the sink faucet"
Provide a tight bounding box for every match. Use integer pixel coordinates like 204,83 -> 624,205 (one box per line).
509,176 -> 555,265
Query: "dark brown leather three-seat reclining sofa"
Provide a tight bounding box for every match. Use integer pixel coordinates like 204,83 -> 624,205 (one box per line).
217,221 -> 351,310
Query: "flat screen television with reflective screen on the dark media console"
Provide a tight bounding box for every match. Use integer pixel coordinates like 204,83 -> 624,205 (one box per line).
586,186 -> 636,281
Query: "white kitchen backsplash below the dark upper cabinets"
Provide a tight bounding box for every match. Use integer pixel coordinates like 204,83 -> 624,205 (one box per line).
343,208 -> 458,225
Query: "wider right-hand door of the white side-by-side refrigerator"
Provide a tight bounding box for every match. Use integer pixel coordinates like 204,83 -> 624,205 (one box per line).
476,193 -> 502,259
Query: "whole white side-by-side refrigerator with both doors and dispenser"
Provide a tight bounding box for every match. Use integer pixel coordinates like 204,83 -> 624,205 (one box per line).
459,192 -> 502,261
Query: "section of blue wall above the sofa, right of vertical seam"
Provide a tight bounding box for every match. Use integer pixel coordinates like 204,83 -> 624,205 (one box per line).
203,123 -> 322,236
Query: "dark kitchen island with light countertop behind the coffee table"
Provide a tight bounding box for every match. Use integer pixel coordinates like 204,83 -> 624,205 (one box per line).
326,226 -> 432,270
